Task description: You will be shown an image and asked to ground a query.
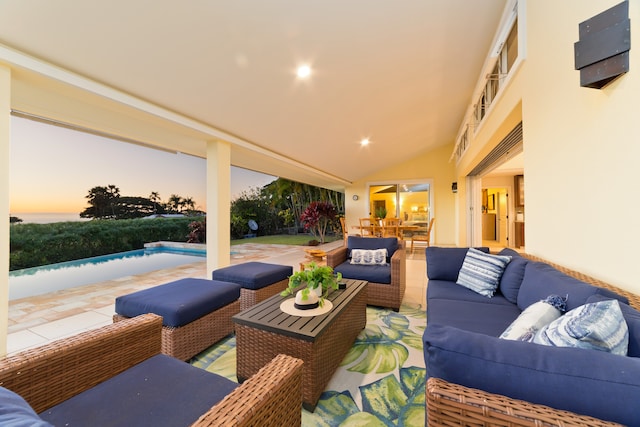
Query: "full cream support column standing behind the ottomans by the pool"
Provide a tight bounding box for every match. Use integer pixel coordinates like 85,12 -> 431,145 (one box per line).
207,141 -> 231,278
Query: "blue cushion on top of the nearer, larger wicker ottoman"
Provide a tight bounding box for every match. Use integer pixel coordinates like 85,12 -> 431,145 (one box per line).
116,278 -> 240,327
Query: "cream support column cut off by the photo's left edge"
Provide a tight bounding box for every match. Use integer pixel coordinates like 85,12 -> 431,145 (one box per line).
0,65 -> 11,357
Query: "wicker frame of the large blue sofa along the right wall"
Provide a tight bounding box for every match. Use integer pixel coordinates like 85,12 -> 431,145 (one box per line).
426,254 -> 640,427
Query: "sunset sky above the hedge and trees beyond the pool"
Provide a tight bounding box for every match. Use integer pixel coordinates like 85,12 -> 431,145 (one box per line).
10,117 -> 275,214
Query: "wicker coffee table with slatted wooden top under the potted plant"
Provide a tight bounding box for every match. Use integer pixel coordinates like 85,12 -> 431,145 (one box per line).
233,279 -> 367,412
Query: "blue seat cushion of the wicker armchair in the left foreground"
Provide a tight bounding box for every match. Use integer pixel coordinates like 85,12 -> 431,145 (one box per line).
40,354 -> 238,427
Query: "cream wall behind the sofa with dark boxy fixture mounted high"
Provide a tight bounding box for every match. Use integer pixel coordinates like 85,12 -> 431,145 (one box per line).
522,0 -> 640,292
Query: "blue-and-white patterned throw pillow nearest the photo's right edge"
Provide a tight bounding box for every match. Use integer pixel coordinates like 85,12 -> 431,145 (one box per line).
533,300 -> 629,356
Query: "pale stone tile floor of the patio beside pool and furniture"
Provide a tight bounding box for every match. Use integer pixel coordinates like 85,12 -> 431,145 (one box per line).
7,241 -> 427,354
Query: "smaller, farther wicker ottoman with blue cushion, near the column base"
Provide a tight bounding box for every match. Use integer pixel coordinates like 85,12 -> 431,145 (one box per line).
211,262 -> 293,311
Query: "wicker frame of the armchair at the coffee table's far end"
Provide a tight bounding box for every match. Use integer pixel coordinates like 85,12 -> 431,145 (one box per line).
327,239 -> 407,311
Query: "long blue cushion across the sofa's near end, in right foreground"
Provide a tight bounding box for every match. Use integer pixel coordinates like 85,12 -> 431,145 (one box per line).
423,326 -> 640,425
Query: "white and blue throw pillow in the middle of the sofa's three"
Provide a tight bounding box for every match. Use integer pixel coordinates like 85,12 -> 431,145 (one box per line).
500,295 -> 567,342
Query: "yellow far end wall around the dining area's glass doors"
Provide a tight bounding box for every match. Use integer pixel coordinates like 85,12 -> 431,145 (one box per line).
345,143 -> 457,245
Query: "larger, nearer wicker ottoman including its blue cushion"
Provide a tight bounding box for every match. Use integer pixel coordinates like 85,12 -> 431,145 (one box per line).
113,278 -> 240,360
